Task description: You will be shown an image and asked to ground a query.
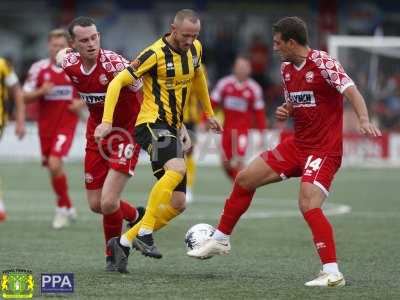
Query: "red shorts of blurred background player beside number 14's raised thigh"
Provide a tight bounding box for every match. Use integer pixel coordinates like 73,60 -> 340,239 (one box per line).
222,129 -> 248,160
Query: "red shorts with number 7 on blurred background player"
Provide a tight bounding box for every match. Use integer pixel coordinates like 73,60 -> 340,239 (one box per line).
39,127 -> 75,166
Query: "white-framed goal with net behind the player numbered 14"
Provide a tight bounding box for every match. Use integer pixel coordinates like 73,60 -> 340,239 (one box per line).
328,35 -> 400,164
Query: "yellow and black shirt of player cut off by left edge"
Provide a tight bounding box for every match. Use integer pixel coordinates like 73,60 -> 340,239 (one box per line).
0,58 -> 18,134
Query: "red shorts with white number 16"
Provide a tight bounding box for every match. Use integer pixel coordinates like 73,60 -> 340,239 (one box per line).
85,135 -> 140,190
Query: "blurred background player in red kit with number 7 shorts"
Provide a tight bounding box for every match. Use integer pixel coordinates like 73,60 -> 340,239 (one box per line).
23,29 -> 84,229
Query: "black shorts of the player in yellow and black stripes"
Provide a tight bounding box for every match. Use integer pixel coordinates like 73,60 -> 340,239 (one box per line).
135,123 -> 186,193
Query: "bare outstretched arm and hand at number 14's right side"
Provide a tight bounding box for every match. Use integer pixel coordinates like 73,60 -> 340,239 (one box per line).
343,86 -> 382,137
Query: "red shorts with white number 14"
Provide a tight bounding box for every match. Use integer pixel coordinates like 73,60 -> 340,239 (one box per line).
261,138 -> 342,196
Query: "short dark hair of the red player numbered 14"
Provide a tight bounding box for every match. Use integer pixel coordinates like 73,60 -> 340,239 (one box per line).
272,17 -> 308,46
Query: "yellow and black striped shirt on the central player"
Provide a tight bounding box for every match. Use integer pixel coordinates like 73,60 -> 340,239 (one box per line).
127,36 -> 213,128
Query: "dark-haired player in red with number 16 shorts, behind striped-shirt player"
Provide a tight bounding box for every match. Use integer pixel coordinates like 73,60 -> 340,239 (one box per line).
57,17 -> 144,271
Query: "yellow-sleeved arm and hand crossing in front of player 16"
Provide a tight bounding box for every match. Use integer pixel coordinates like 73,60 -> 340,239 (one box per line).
94,69 -> 136,141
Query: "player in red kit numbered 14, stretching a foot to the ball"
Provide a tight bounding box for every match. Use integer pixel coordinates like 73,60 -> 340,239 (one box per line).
188,17 -> 381,287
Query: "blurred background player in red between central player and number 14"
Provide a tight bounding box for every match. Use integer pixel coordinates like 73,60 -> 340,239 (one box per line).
211,56 -> 266,181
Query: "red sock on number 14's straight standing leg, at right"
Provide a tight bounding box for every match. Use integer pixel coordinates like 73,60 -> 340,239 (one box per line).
303,208 -> 336,264
